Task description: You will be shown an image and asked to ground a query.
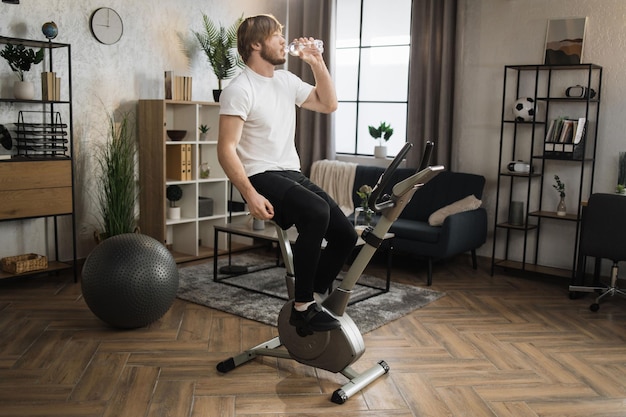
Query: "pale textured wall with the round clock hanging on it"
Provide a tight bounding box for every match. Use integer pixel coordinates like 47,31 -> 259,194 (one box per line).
0,0 -> 287,259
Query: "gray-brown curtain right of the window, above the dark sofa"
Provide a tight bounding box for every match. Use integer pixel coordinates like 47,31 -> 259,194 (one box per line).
407,0 -> 457,168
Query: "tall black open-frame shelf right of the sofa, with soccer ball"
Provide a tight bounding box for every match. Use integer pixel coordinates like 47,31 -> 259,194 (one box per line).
491,64 -> 602,278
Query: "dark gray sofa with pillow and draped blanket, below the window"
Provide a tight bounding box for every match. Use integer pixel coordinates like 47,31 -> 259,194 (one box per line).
352,165 -> 487,285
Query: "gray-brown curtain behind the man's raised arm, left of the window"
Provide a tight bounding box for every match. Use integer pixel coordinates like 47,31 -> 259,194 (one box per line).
285,0 -> 335,175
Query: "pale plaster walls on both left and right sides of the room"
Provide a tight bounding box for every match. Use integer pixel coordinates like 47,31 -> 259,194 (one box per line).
0,0 -> 626,266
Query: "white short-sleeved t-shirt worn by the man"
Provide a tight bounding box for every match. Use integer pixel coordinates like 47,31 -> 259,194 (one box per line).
220,67 -> 313,177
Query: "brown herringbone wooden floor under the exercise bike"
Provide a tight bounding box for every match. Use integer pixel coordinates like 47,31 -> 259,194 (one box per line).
0,250 -> 626,417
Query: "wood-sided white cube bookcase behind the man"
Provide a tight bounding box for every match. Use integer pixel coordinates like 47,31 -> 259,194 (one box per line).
138,100 -> 245,262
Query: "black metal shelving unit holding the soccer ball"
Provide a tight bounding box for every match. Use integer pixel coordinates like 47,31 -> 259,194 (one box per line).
491,64 -> 602,279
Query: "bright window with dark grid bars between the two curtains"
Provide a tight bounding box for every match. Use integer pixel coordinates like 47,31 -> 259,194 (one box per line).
335,0 -> 411,155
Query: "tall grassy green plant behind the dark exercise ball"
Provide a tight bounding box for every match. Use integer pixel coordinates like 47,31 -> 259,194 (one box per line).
97,113 -> 139,238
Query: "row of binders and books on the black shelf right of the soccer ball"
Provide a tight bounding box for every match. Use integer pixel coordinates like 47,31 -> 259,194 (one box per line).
544,117 -> 587,159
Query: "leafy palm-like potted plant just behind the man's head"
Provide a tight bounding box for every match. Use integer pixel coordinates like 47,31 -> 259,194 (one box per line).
193,13 -> 243,101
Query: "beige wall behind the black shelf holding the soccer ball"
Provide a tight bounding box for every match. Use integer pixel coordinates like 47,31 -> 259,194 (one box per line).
453,0 -> 626,267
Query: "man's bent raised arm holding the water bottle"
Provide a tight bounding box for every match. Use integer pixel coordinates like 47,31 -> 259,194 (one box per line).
300,38 -> 337,113
